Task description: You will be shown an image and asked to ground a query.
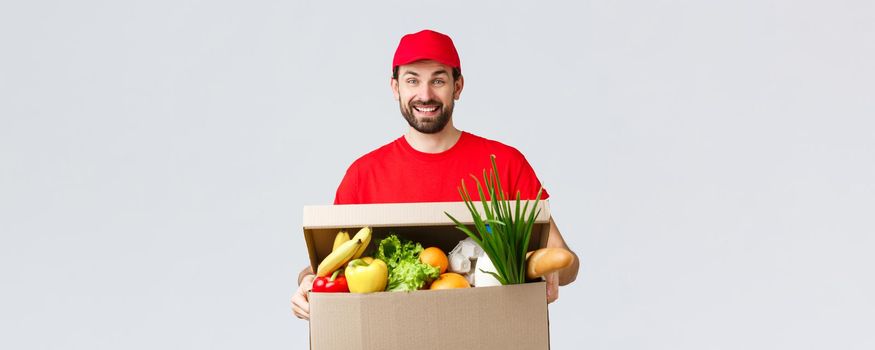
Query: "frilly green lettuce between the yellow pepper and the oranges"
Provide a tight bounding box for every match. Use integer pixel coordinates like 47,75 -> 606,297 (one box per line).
376,235 -> 440,292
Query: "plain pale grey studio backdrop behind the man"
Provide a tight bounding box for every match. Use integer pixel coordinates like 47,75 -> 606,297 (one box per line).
0,0 -> 875,350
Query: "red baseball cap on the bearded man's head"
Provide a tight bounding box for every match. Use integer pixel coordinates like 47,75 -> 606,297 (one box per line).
392,29 -> 462,72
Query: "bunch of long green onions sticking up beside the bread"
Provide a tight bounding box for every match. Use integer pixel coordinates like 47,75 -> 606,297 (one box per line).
444,155 -> 544,285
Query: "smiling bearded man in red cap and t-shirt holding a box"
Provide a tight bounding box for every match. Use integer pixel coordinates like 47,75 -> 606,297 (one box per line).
291,30 -> 579,319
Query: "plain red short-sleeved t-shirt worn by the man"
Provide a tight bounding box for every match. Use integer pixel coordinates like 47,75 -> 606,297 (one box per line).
334,132 -> 549,204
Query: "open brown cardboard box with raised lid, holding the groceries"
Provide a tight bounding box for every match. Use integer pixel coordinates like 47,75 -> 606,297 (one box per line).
304,202 -> 550,350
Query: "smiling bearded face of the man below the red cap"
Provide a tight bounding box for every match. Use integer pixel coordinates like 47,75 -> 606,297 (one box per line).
392,60 -> 463,134
